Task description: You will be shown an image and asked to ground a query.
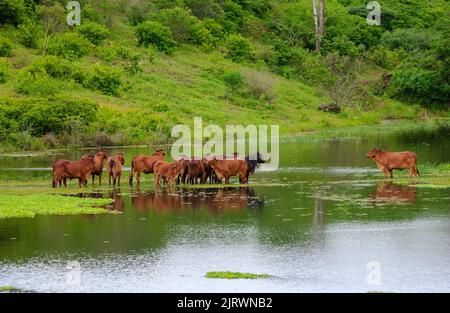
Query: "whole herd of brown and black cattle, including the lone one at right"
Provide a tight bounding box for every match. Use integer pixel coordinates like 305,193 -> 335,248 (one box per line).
52,148 -> 419,187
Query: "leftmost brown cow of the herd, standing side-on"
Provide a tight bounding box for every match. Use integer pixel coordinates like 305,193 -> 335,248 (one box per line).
52,155 -> 95,188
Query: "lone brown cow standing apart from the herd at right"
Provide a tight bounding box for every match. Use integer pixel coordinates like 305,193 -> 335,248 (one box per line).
367,148 -> 419,178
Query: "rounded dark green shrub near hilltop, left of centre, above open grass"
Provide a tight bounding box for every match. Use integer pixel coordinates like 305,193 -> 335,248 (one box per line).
136,21 -> 176,52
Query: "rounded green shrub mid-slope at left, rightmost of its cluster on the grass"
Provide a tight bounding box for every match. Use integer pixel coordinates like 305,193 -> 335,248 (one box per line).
85,65 -> 122,96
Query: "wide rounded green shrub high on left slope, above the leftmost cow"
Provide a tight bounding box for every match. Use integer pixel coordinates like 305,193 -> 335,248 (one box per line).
48,33 -> 90,59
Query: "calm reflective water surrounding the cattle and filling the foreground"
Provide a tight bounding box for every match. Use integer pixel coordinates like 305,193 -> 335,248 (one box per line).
0,123 -> 450,292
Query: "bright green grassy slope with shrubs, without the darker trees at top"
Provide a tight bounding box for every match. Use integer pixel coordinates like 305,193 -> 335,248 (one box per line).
0,0 -> 449,151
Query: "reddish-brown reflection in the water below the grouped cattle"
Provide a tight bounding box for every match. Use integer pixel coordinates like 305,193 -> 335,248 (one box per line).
132,187 -> 264,214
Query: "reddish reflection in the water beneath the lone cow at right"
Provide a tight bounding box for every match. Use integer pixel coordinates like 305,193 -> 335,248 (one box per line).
372,182 -> 416,203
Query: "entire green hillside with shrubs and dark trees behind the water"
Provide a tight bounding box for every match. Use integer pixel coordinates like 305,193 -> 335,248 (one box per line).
0,0 -> 450,150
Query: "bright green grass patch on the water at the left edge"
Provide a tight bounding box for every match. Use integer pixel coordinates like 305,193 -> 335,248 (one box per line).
0,194 -> 112,219
